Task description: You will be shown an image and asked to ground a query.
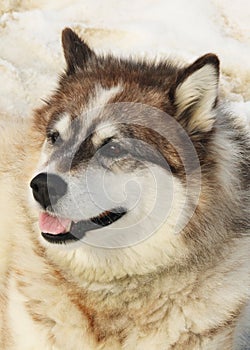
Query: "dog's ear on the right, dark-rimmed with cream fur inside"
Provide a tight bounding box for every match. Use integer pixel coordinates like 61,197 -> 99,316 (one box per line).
169,54 -> 220,133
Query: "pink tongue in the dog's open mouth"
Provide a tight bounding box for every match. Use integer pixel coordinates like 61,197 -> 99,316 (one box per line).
39,213 -> 71,235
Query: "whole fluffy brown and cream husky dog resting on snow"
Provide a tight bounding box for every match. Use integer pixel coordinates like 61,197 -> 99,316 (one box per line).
0,28 -> 250,350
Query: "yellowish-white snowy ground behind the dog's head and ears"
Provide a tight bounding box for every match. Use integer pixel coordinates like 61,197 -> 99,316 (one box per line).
0,0 -> 250,123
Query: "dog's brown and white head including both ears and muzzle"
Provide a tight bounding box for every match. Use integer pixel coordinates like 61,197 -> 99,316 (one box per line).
31,29 -> 219,253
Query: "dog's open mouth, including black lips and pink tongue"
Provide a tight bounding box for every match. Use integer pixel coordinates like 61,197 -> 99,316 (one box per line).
39,208 -> 127,243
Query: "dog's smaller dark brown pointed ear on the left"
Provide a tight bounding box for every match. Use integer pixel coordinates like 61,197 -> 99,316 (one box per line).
62,28 -> 95,75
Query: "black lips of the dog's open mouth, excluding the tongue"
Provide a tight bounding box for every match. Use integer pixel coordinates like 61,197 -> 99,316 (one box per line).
41,207 -> 127,243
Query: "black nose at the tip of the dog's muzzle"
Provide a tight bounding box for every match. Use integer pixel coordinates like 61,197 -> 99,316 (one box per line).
30,173 -> 67,209
